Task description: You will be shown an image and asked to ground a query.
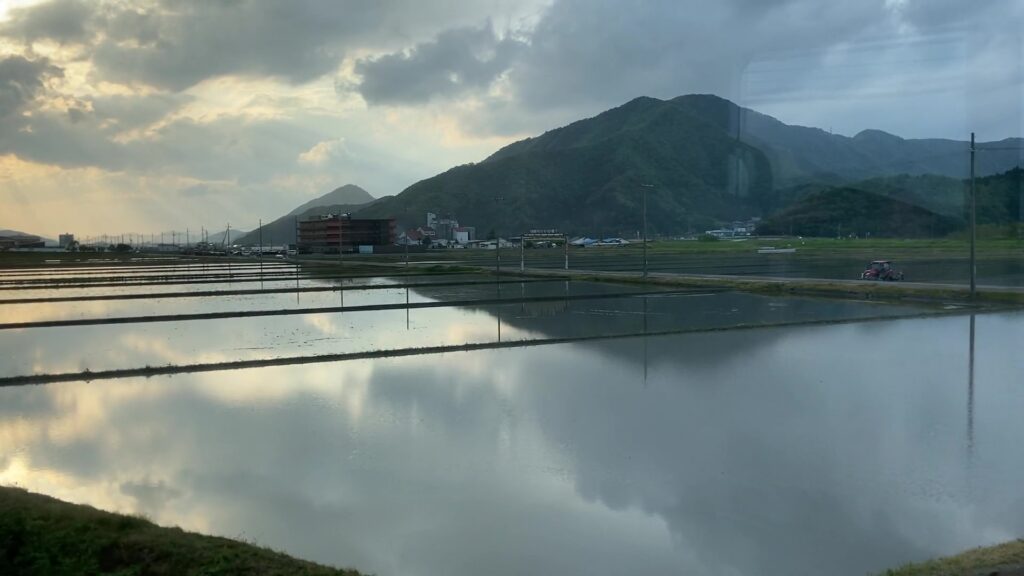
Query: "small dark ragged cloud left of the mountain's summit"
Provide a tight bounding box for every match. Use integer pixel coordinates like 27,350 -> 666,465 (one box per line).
355,24 -> 525,104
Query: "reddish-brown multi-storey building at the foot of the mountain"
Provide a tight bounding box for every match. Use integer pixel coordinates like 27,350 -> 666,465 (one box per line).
298,214 -> 395,254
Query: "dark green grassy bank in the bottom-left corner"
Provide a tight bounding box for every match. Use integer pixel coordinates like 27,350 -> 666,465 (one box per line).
0,487 -> 358,576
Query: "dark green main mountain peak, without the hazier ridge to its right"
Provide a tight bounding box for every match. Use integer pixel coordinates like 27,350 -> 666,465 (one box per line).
358,98 -> 774,236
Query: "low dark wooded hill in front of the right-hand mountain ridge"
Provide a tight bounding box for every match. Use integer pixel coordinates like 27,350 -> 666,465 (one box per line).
758,187 -> 964,238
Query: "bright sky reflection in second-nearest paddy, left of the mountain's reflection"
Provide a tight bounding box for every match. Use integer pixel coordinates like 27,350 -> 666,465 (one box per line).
0,298 -> 527,376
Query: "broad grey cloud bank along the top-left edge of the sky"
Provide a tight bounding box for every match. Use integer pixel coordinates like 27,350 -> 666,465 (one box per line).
0,0 -> 528,90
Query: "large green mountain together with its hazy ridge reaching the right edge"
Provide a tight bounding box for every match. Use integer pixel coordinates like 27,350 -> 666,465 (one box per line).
356,94 -> 1024,237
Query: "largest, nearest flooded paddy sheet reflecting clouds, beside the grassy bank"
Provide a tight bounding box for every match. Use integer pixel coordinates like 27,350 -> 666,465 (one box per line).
0,312 -> 1024,575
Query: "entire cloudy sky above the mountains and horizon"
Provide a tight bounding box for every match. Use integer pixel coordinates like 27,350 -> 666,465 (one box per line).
0,0 -> 1024,238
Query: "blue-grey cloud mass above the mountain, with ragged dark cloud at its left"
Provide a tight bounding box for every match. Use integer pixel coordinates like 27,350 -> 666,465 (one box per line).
356,0 -> 1024,137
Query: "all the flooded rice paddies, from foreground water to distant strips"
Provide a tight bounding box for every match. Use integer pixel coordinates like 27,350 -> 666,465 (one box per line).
0,256 -> 1024,575
